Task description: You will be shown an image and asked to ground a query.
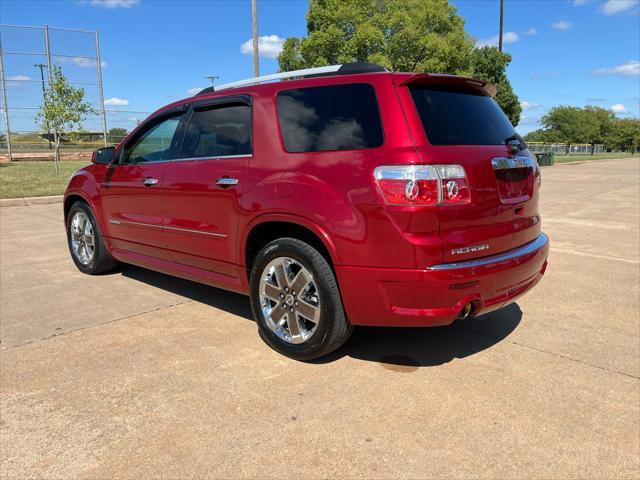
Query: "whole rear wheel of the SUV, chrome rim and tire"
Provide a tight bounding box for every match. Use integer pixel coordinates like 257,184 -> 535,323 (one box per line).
250,238 -> 353,360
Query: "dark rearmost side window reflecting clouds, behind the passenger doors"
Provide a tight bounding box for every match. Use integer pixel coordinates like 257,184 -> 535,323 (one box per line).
277,84 -> 383,152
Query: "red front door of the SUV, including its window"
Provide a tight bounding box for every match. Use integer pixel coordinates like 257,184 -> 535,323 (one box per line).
101,112 -> 183,260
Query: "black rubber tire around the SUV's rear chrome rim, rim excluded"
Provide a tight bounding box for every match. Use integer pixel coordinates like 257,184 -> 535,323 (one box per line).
250,238 -> 353,361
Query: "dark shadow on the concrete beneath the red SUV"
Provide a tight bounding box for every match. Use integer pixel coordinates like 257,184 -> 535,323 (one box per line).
120,265 -> 522,366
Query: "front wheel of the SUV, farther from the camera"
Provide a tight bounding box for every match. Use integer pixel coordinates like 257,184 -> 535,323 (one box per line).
67,201 -> 117,275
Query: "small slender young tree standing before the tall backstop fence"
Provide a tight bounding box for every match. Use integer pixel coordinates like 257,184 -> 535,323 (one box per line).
37,65 -> 96,171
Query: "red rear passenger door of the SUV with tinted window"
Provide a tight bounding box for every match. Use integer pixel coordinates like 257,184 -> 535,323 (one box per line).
162,95 -> 252,276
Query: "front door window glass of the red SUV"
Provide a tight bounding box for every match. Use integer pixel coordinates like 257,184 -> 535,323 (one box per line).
122,114 -> 182,163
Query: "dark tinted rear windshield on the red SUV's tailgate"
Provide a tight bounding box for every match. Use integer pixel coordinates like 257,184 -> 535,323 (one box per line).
411,86 -> 516,145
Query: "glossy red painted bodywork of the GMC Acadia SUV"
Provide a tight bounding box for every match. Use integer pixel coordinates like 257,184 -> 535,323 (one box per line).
66,73 -> 548,326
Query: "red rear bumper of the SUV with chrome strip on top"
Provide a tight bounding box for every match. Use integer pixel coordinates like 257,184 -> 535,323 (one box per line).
336,233 -> 549,326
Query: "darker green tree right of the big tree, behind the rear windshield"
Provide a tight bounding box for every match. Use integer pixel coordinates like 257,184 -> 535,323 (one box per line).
471,47 -> 522,125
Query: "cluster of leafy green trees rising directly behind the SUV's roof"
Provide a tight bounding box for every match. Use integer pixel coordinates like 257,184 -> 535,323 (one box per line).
278,0 -> 522,125
